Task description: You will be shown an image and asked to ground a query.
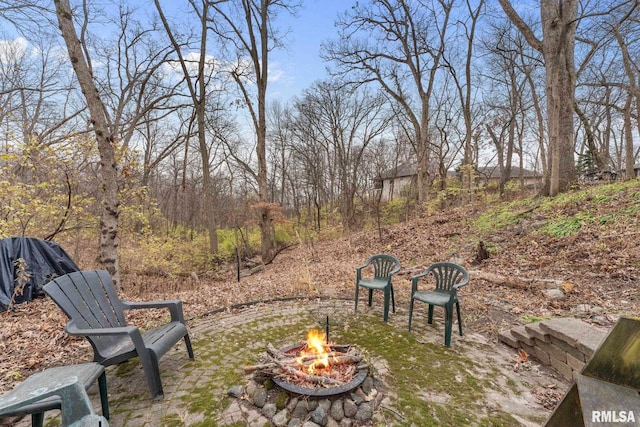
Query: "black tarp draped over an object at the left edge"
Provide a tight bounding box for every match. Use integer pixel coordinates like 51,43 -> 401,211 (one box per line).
0,237 -> 80,311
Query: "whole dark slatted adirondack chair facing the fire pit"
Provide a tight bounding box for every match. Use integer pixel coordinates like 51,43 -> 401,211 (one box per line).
43,270 -> 193,399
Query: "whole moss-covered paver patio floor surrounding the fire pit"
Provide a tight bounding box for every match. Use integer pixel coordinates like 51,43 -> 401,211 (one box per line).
41,300 -> 550,427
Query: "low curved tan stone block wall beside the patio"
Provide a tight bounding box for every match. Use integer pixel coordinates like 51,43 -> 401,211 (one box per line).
498,317 -> 608,380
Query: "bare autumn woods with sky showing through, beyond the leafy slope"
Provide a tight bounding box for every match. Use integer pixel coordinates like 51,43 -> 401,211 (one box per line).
0,0 -> 640,282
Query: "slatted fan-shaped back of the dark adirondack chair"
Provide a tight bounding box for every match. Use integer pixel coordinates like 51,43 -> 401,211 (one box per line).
47,270 -> 127,362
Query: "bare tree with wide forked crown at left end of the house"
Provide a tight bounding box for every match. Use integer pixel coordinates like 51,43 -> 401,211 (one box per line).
323,0 -> 454,206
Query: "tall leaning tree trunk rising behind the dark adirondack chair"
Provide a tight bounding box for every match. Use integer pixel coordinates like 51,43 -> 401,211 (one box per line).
54,0 -> 121,288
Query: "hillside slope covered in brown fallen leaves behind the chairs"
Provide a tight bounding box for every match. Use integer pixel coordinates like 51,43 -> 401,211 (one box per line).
0,180 -> 640,398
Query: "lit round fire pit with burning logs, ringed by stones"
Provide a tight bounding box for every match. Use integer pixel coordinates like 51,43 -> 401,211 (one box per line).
223,330 -> 383,426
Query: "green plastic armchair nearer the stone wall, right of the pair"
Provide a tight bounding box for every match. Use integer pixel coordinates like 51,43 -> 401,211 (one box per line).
409,262 -> 469,347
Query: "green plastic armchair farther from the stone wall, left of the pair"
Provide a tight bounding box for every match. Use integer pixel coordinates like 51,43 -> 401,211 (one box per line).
355,254 -> 400,322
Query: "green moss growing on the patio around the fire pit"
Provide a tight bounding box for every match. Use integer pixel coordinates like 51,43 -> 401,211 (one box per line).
174,308 -> 540,427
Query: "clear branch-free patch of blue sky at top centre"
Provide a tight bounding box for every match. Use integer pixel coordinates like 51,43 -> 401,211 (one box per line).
268,0 -> 353,102
